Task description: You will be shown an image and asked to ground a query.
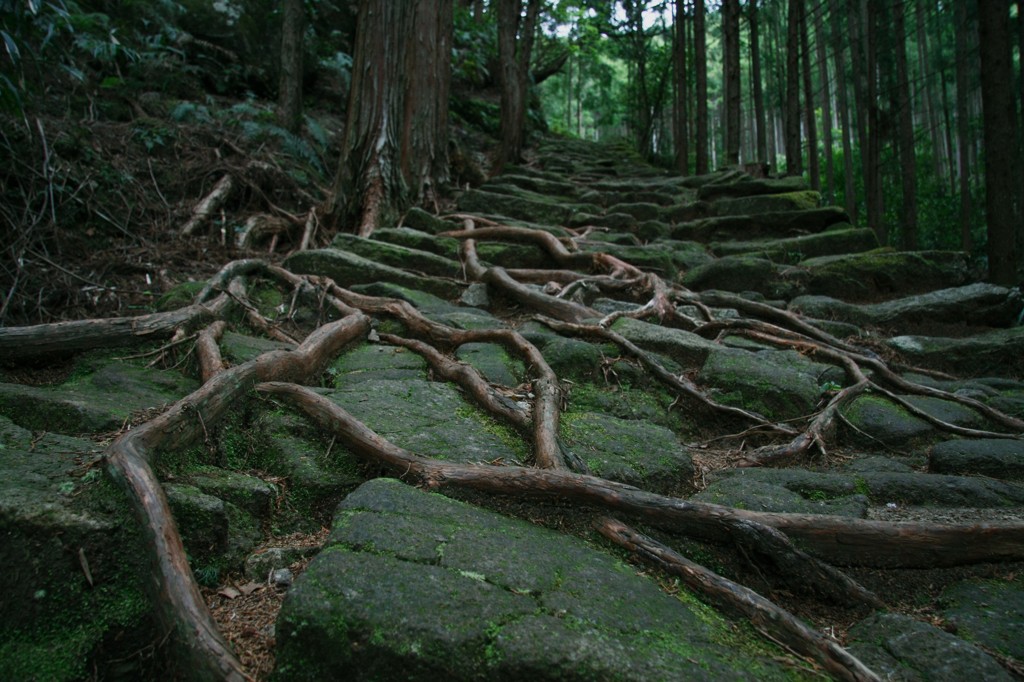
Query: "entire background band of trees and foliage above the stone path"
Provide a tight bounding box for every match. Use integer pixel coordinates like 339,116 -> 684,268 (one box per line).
0,0 -> 1024,285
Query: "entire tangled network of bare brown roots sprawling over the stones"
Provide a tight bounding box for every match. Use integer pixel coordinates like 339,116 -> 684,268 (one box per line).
8,235 -> 1024,680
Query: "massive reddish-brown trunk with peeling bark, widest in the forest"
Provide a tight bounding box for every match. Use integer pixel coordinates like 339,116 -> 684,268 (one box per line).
327,0 -> 453,237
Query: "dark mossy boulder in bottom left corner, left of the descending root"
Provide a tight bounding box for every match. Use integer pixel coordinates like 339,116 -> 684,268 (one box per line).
0,417 -> 153,681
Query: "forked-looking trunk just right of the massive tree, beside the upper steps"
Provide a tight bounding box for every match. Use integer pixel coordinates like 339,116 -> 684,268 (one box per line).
495,0 -> 541,168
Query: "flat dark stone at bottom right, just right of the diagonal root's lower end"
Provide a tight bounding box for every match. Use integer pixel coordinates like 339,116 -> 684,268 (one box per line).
847,613 -> 1013,682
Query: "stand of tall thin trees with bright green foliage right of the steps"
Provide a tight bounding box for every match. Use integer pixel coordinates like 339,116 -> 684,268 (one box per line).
541,0 -> 1024,284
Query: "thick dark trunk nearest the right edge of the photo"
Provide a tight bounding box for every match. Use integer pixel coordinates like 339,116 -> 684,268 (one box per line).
978,0 -> 1020,286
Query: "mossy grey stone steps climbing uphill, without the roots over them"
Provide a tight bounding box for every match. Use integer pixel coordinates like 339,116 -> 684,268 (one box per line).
0,135 -> 1024,680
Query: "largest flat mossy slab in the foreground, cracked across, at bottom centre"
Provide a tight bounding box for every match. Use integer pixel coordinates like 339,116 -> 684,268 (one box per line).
274,479 -> 806,681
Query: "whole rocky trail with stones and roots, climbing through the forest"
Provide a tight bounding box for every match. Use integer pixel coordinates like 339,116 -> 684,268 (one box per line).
0,135 -> 1024,680
